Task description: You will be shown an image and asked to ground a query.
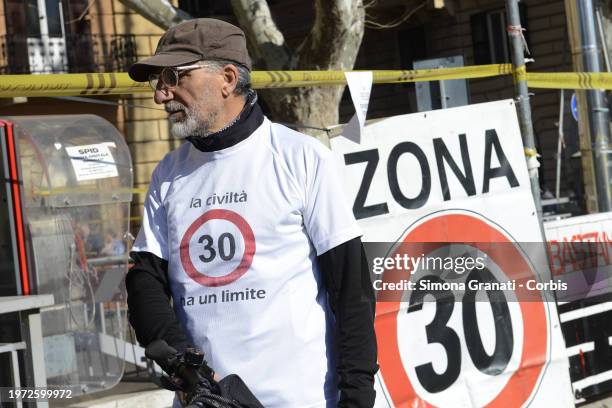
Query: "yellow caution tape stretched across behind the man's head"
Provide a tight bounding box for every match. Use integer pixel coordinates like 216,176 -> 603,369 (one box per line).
0,64 -> 612,98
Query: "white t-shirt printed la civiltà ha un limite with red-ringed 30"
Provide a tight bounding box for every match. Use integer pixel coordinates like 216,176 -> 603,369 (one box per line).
132,119 -> 361,408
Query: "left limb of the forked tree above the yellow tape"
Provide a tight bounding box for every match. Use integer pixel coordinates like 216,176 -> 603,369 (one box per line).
232,0 -> 292,70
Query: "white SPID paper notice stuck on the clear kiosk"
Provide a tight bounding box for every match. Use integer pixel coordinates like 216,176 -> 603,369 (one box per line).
66,143 -> 119,181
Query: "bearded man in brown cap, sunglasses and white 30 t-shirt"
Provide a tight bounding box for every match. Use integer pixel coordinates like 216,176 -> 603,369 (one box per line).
126,19 -> 378,407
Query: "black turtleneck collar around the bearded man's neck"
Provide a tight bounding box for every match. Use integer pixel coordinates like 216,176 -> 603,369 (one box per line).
187,91 -> 264,152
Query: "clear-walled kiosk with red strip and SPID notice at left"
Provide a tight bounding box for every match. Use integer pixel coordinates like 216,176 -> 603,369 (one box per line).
0,115 -> 133,396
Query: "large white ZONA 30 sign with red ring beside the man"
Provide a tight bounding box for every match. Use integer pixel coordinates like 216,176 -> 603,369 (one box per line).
331,101 -> 573,407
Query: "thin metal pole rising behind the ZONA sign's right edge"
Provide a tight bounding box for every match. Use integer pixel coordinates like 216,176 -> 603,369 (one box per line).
506,0 -> 542,222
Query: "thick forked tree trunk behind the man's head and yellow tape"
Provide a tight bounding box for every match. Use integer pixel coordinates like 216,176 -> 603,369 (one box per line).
232,0 -> 365,128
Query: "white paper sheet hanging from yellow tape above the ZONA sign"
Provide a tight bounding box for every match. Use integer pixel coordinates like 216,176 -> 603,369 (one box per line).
342,72 -> 373,143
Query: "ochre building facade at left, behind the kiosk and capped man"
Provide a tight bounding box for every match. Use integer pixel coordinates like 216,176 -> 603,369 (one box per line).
0,0 -> 177,229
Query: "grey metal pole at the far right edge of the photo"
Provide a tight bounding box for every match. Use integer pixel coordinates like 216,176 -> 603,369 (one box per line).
578,0 -> 612,212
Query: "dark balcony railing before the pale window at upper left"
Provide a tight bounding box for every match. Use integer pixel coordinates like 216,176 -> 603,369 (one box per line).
0,34 -> 138,74
